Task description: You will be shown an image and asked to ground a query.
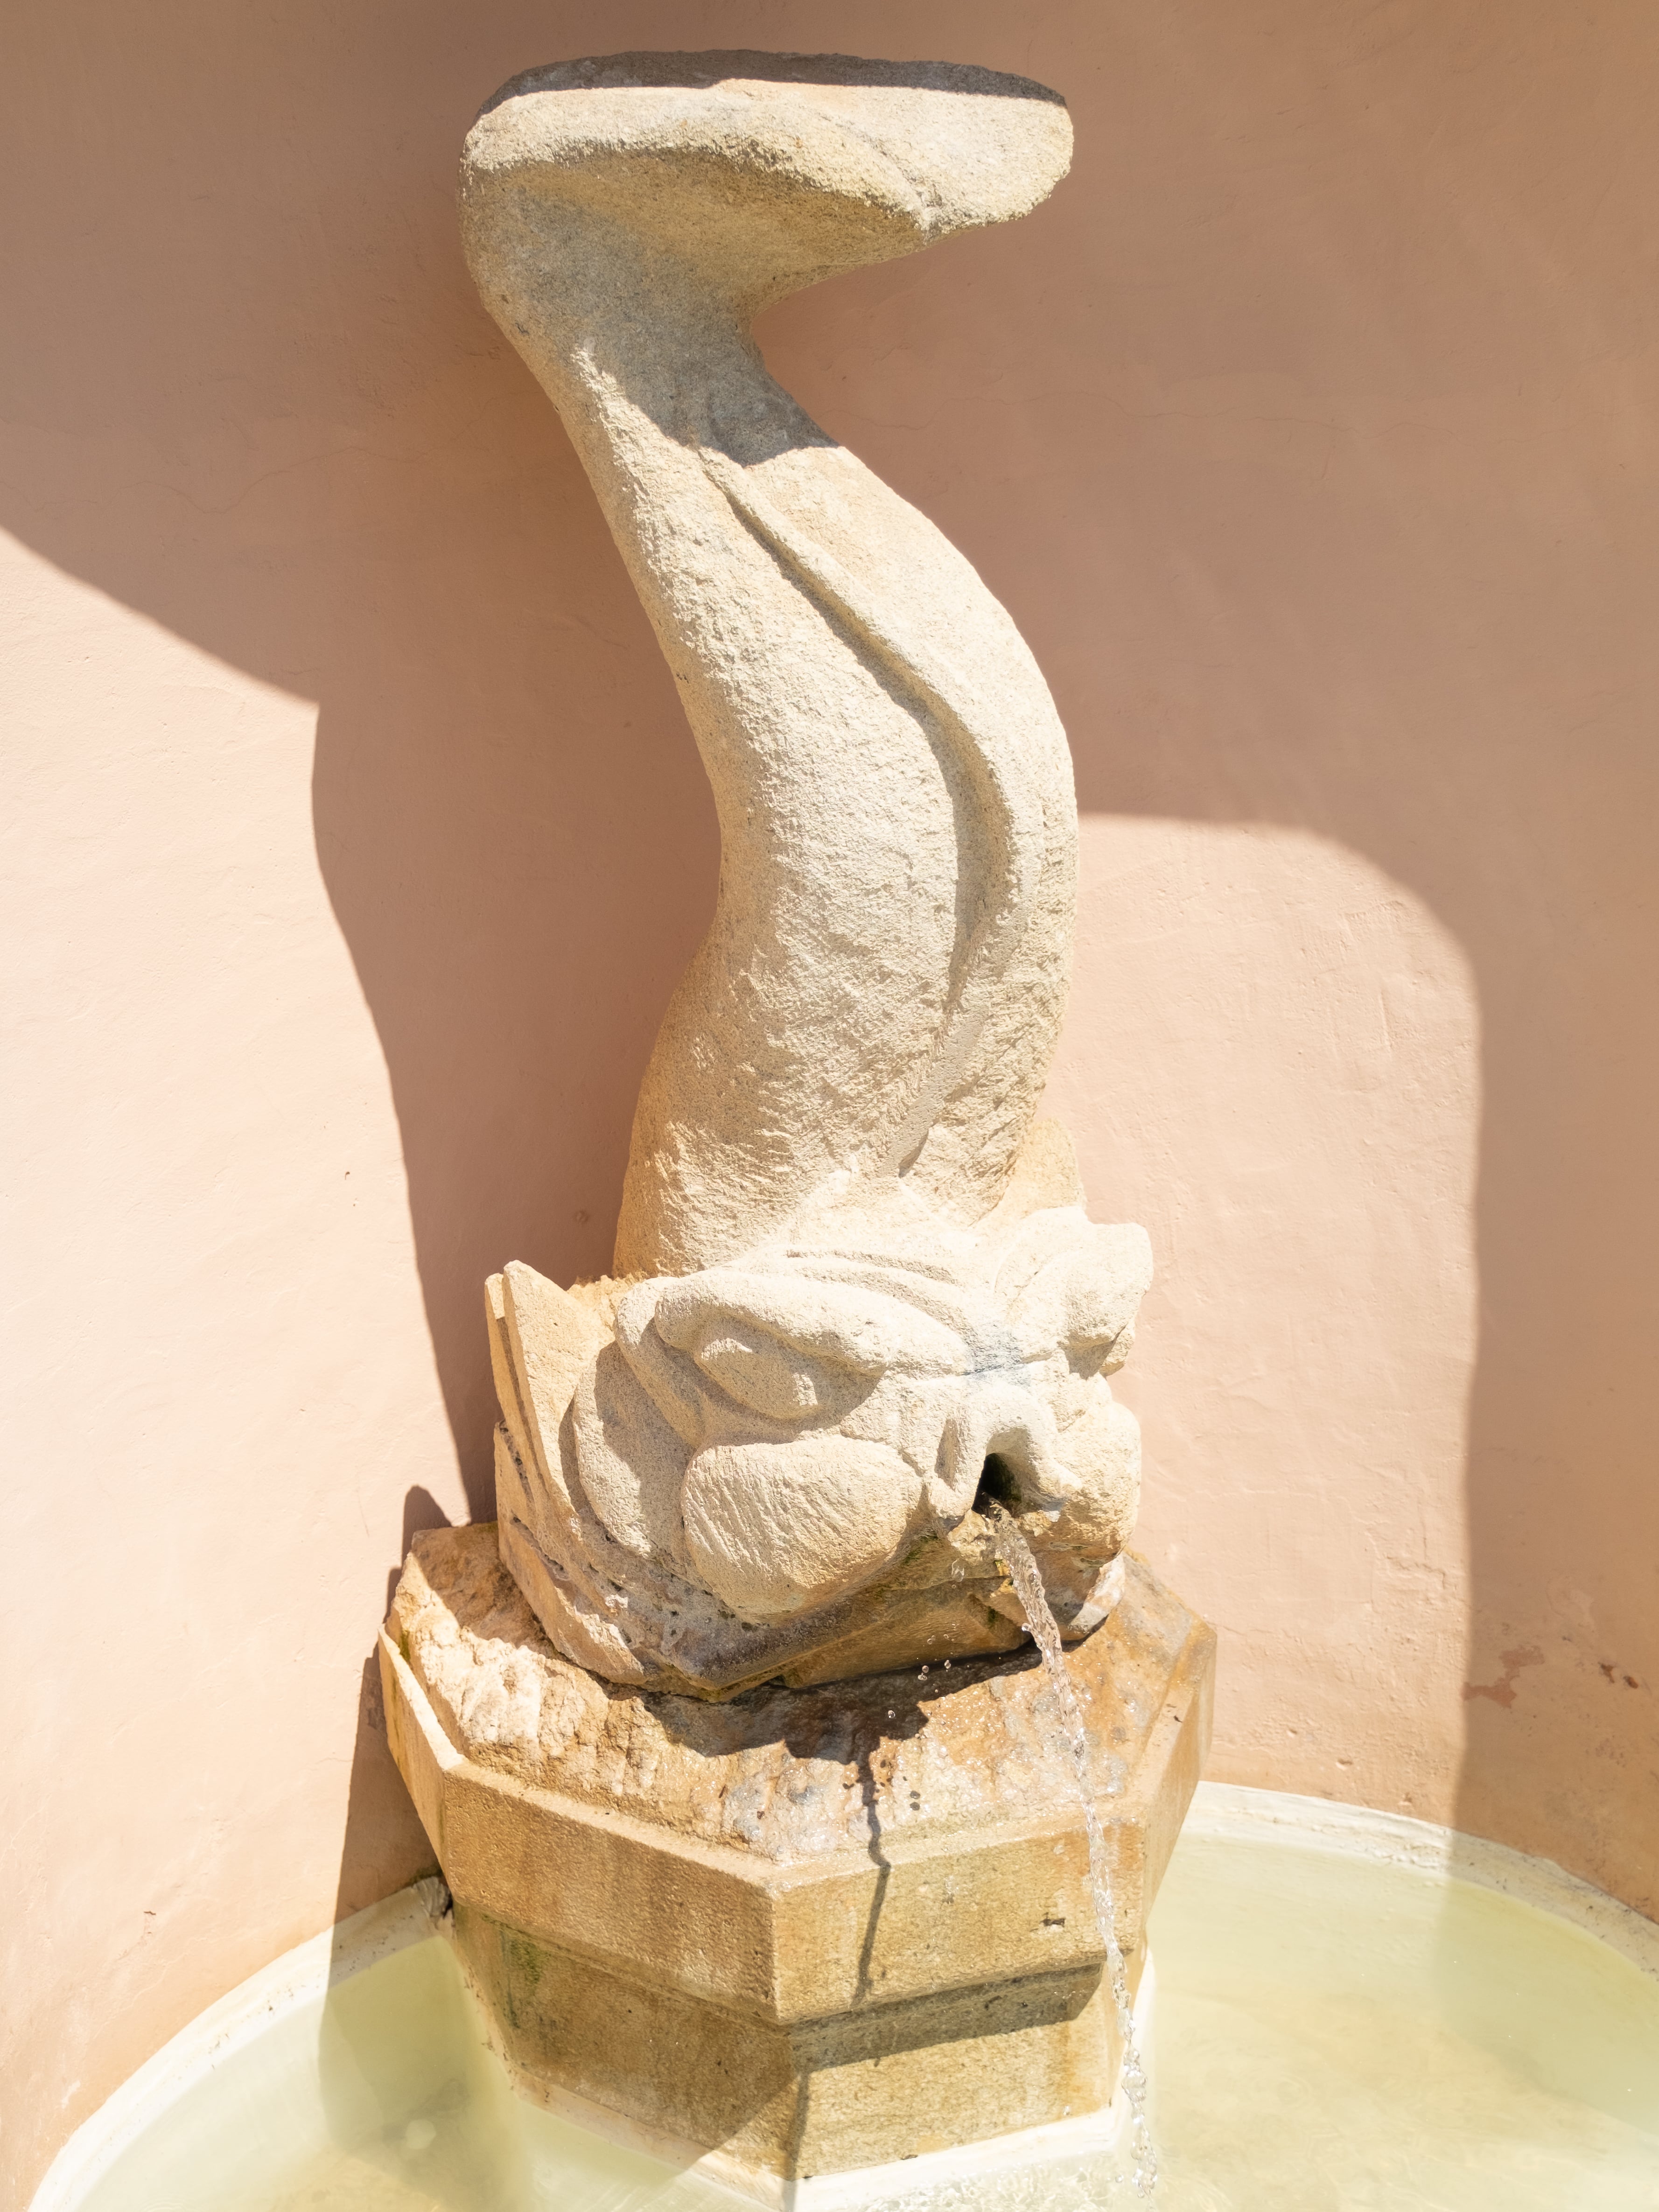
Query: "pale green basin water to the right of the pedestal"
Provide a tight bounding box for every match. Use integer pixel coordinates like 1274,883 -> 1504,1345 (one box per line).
1153,1838 -> 1659,2212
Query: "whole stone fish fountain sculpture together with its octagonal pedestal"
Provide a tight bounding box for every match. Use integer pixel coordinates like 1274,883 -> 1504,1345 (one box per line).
385,53 -> 1210,2177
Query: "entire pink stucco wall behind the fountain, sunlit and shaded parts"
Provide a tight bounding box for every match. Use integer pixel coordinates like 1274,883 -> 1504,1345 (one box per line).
0,0 -> 1659,2205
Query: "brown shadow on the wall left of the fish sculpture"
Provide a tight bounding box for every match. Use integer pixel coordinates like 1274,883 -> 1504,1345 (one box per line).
0,4 -> 717,1515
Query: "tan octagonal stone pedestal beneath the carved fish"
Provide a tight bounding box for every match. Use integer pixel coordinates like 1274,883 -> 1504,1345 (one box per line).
380,1526 -> 1214,2194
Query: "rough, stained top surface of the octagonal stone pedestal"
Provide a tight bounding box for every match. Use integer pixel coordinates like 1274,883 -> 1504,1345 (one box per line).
392,1526 -> 1195,1860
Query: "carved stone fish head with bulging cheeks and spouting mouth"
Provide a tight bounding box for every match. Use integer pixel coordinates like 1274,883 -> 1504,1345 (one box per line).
575,1186 -> 1150,1619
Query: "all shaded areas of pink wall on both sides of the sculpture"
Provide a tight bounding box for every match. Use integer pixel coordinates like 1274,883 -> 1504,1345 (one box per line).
0,0 -> 1659,1911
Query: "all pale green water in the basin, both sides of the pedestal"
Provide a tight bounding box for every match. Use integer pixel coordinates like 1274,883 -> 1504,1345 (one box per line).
84,1838 -> 1659,2212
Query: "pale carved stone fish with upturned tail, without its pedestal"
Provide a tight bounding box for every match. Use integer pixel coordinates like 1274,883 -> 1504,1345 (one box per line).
462,53 -> 1150,1694
